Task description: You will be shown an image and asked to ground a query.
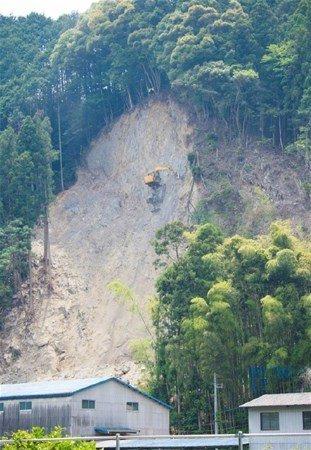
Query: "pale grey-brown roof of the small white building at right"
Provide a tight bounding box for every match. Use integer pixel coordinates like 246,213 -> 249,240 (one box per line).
240,392 -> 311,408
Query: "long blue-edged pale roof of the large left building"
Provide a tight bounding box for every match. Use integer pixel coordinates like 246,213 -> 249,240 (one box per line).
0,377 -> 171,409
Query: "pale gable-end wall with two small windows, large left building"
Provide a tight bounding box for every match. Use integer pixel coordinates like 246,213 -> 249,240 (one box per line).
71,380 -> 169,436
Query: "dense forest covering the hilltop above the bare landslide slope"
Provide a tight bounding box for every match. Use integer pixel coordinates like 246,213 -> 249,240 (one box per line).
0,0 -> 311,316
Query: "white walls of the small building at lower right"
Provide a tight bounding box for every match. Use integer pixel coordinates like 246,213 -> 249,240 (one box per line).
248,407 -> 311,450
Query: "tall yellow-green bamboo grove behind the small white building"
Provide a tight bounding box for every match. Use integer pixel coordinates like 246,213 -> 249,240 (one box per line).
152,222 -> 311,432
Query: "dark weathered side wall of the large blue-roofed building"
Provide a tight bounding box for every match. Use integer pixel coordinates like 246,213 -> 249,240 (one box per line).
0,397 -> 71,436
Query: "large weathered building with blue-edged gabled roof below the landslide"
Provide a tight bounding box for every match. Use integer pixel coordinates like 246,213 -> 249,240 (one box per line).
0,377 -> 170,436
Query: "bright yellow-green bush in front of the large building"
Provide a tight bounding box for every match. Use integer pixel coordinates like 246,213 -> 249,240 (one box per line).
4,427 -> 96,450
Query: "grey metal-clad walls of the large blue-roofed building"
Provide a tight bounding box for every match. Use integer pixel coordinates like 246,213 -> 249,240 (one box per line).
0,380 -> 169,436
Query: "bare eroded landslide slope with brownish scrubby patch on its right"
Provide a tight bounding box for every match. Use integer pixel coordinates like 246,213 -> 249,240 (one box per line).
0,96 -> 310,382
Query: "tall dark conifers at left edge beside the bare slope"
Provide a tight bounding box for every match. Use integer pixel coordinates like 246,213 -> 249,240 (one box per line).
0,115 -> 53,317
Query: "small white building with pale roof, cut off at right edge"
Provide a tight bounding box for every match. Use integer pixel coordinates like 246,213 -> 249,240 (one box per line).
241,392 -> 311,450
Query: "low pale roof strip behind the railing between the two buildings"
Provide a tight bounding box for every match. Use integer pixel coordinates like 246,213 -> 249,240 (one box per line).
96,436 -> 248,448
